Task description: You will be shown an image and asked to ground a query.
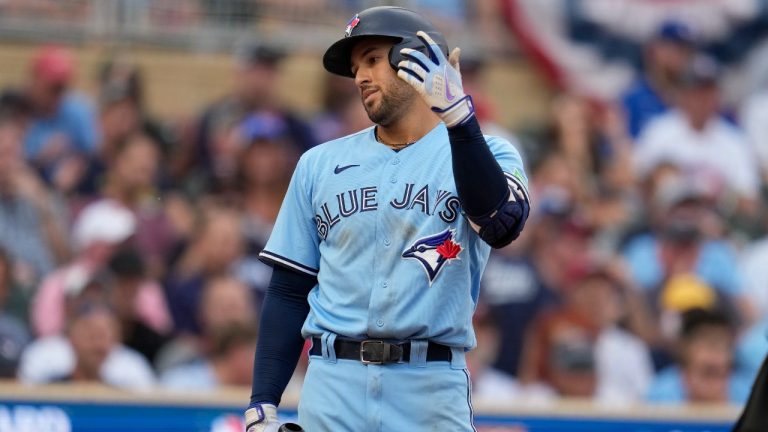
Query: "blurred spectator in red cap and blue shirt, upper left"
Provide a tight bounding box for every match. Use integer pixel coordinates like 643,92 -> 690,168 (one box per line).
14,45 -> 98,183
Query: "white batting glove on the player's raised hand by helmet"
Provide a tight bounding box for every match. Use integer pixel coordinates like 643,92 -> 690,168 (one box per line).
397,31 -> 475,128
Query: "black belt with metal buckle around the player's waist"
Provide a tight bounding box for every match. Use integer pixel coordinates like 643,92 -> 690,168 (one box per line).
309,337 -> 451,364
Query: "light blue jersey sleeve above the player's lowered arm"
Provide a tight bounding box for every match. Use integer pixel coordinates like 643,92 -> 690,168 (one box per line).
259,158 -> 320,276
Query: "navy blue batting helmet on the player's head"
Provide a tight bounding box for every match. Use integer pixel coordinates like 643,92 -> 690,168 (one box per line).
323,6 -> 449,78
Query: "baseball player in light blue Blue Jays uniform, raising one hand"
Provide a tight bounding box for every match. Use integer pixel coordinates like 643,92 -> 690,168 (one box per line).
245,7 -> 529,432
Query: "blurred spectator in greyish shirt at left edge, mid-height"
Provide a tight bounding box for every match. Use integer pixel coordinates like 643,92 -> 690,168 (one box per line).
0,113 -> 69,285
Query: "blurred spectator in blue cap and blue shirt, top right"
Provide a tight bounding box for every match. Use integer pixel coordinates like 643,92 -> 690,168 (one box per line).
621,19 -> 695,138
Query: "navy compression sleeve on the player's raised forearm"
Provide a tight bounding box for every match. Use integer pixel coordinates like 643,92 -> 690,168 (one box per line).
448,116 -> 509,217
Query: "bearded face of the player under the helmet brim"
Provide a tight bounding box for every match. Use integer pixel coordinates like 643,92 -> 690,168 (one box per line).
351,38 -> 416,126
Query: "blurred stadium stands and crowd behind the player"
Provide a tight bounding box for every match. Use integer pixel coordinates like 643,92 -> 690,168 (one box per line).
0,0 -> 768,432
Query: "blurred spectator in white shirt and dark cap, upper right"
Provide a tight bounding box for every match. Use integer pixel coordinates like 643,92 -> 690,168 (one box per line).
633,55 -> 760,215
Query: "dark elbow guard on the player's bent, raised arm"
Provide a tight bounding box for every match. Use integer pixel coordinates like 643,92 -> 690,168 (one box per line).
468,173 -> 531,249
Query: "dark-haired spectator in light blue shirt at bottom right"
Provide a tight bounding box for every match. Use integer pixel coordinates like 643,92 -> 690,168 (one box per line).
647,309 -> 754,404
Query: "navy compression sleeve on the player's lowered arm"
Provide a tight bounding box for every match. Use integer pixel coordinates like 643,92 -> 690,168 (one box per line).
251,265 -> 317,406
